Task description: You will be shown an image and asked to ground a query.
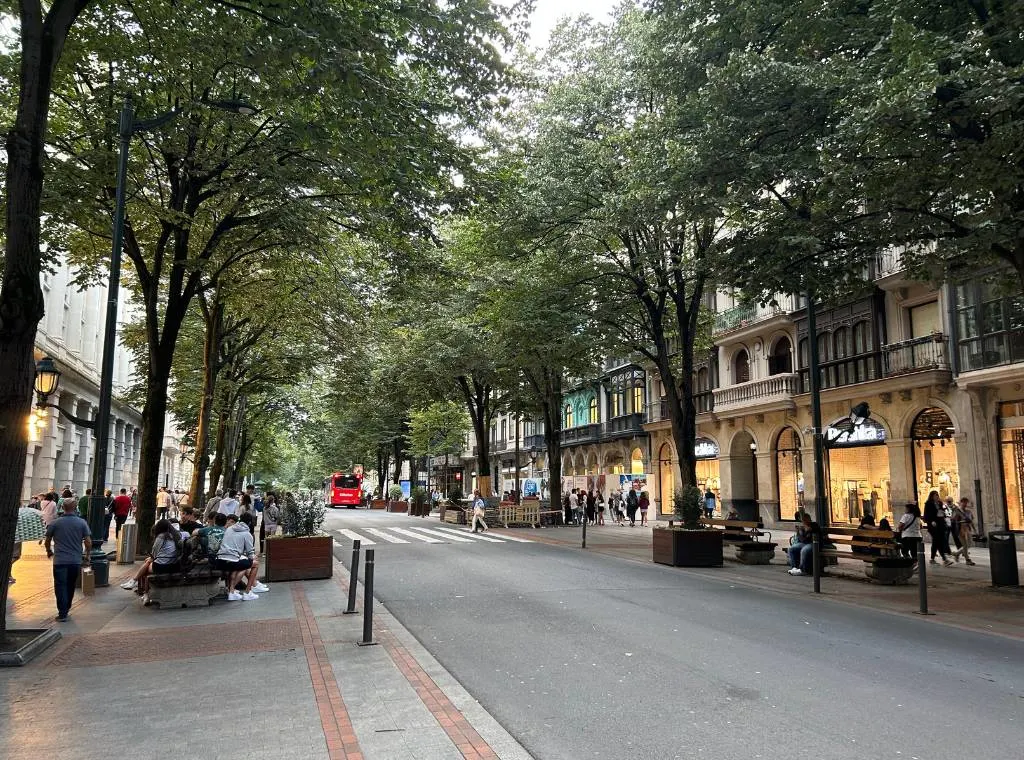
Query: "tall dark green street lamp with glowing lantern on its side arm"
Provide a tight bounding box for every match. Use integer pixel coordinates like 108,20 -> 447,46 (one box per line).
36,97 -> 256,586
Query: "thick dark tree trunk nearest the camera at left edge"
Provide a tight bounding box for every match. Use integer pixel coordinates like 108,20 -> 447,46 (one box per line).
0,0 -> 89,638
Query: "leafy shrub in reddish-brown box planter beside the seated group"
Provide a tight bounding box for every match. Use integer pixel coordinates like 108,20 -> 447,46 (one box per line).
263,493 -> 334,582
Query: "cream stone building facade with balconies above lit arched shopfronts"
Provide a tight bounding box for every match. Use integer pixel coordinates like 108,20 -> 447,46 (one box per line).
644,253 -> 1024,531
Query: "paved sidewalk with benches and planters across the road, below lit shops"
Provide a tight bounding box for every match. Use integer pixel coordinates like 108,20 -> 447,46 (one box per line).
496,522 -> 1024,639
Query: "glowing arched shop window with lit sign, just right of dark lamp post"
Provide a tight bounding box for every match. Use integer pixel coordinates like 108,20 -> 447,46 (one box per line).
825,420 -> 893,523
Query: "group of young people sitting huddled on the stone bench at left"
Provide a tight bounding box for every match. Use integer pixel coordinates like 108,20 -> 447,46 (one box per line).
121,507 -> 270,601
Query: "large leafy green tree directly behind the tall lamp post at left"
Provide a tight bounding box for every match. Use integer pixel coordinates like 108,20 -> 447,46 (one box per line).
45,0 -> 516,549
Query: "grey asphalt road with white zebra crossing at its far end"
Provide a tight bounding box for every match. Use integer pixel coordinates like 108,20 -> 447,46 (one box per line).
327,511 -> 1024,760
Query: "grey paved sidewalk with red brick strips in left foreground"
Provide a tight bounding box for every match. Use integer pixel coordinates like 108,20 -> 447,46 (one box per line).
6,544 -> 529,760
